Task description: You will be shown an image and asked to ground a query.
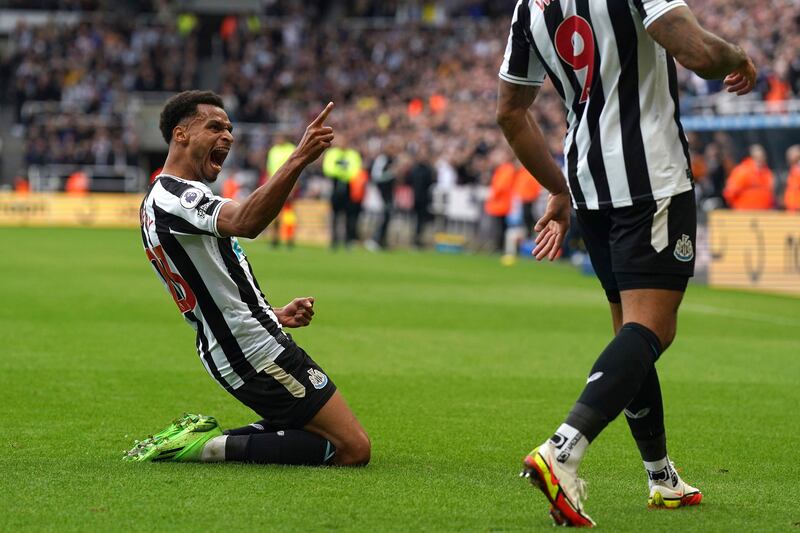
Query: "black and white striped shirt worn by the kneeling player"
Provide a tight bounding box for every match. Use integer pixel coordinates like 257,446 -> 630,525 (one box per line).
140,174 -> 292,390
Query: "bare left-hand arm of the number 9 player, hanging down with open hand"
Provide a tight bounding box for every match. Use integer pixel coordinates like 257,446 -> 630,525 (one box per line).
497,80 -> 571,261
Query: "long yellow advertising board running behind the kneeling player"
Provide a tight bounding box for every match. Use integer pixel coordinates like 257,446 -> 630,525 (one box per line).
0,192 -> 330,244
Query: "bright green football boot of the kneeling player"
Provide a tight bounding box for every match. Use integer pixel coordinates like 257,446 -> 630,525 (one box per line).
122,414 -> 222,462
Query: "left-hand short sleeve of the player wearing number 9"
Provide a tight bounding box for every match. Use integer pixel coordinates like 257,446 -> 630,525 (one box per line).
499,0 -> 545,86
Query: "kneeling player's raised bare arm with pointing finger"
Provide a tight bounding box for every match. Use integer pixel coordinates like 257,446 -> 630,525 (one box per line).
217,103 -> 333,239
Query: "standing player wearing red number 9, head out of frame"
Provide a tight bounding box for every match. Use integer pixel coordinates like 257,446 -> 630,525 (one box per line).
497,0 -> 756,526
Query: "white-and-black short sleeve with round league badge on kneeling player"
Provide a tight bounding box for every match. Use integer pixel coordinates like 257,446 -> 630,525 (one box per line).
153,177 -> 230,237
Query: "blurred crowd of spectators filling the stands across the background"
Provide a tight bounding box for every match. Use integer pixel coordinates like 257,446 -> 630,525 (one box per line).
0,0 -> 800,245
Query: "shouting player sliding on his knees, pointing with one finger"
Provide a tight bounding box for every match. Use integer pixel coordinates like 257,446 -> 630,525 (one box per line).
125,91 -> 370,465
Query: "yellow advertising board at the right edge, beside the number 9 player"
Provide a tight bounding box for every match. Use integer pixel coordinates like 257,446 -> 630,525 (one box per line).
709,211 -> 800,295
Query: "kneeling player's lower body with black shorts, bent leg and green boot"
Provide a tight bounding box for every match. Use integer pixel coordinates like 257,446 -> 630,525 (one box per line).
126,345 -> 370,465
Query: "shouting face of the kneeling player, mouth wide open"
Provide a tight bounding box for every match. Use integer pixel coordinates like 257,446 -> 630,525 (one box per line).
187,104 -> 233,181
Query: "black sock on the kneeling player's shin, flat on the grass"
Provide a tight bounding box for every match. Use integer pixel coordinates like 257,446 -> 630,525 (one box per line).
225,429 -> 336,466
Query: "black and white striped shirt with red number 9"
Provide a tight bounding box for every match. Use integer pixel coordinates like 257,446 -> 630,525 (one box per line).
500,0 -> 692,209
